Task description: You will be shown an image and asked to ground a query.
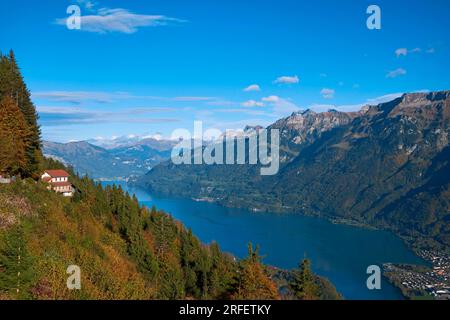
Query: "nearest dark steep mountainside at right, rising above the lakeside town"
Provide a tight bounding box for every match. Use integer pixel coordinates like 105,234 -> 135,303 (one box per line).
272,92 -> 450,249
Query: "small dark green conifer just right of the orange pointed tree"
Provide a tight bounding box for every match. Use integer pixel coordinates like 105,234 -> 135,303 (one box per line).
290,259 -> 320,300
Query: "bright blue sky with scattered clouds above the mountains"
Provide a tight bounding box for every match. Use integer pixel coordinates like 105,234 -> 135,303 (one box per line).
0,0 -> 450,141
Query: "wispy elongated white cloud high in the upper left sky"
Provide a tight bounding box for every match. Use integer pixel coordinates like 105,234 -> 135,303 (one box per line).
56,8 -> 185,34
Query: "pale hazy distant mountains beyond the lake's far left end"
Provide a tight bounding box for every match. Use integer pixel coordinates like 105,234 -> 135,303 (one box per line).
44,138 -> 174,180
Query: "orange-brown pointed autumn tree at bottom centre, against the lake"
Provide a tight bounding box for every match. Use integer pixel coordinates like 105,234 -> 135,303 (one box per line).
232,244 -> 279,300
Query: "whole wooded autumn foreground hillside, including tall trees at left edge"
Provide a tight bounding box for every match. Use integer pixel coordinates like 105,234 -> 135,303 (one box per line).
0,52 -> 339,299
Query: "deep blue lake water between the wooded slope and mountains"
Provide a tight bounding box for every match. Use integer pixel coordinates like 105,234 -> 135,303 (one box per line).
101,182 -> 424,299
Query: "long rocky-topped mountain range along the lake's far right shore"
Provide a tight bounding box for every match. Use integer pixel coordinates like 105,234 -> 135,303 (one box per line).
139,91 -> 450,250
